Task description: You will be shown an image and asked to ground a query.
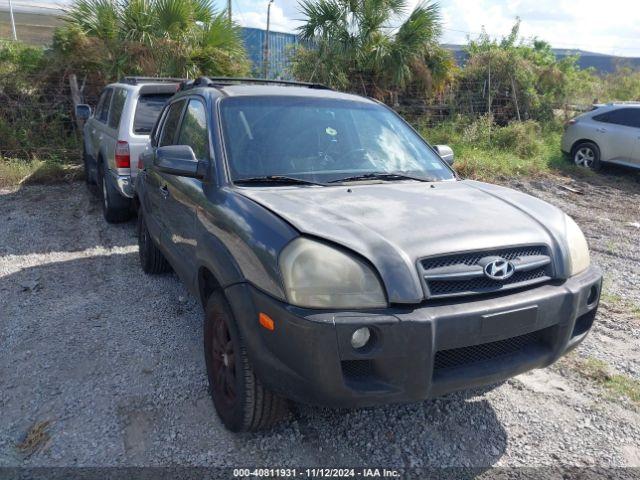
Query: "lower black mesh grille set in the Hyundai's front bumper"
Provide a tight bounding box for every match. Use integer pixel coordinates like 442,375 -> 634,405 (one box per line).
434,329 -> 548,374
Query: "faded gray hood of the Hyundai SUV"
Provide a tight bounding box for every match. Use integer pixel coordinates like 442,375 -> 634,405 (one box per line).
238,180 -> 564,303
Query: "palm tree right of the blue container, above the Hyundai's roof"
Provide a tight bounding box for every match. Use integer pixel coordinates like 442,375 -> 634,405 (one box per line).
293,0 -> 441,96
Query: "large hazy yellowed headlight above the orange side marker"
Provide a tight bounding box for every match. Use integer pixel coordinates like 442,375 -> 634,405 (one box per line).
280,238 -> 387,308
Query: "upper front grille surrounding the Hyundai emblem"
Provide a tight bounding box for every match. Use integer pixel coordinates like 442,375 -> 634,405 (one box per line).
419,245 -> 552,299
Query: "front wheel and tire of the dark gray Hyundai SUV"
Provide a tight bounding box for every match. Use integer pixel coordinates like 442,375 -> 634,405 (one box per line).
204,291 -> 288,432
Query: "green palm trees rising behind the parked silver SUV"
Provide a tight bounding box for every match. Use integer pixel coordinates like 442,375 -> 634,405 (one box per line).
60,0 -> 248,78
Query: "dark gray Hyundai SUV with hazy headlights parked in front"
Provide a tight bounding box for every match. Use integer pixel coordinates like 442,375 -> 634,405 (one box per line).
137,78 -> 602,431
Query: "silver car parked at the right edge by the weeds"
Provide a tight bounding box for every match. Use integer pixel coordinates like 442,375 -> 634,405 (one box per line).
562,103 -> 640,170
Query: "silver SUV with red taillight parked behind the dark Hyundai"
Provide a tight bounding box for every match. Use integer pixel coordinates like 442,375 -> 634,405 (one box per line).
76,77 -> 181,223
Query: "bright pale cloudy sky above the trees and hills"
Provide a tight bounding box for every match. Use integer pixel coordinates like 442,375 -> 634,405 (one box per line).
7,0 -> 640,57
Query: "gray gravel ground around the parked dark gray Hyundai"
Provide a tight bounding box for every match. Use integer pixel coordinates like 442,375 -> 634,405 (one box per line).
0,171 -> 640,467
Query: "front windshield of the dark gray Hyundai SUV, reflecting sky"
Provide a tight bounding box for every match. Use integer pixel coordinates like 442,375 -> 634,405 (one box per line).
220,97 -> 454,183
